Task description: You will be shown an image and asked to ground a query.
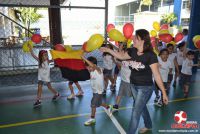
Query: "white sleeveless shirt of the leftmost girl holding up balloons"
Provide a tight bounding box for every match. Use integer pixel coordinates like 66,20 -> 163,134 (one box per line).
38,61 -> 50,82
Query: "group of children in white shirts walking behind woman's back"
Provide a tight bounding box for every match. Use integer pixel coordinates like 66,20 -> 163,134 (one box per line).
154,41 -> 199,107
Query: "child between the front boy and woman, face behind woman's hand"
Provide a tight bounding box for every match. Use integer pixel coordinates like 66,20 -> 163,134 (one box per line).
103,44 -> 116,94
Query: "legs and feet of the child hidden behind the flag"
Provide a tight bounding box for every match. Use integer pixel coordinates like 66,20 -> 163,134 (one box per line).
67,81 -> 84,100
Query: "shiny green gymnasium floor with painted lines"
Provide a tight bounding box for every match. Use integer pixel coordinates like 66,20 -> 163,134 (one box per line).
0,71 -> 200,134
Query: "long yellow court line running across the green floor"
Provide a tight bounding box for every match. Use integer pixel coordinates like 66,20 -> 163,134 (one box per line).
0,96 -> 200,128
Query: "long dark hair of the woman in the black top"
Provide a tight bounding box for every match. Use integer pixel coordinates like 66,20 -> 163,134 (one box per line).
135,29 -> 153,52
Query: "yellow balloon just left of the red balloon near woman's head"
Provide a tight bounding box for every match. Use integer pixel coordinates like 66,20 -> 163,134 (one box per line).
108,29 -> 126,42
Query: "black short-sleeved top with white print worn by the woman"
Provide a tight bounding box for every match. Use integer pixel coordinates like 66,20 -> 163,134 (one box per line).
128,48 -> 158,86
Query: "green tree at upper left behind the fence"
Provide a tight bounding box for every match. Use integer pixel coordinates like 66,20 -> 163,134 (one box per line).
15,7 -> 43,37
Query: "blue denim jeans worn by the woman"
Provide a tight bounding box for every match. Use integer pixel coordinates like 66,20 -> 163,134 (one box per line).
128,84 -> 153,134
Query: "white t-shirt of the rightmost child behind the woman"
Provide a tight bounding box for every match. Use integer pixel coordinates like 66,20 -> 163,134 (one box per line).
181,58 -> 194,75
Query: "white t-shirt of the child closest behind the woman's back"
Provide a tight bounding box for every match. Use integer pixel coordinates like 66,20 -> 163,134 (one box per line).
158,57 -> 172,82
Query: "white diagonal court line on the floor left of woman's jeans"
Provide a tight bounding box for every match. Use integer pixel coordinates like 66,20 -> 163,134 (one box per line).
104,108 -> 126,134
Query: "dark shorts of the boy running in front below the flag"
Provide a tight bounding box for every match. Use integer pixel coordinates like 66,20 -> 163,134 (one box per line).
91,93 -> 102,108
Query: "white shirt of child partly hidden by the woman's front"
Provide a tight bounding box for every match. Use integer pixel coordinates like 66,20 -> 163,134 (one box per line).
121,61 -> 131,83
